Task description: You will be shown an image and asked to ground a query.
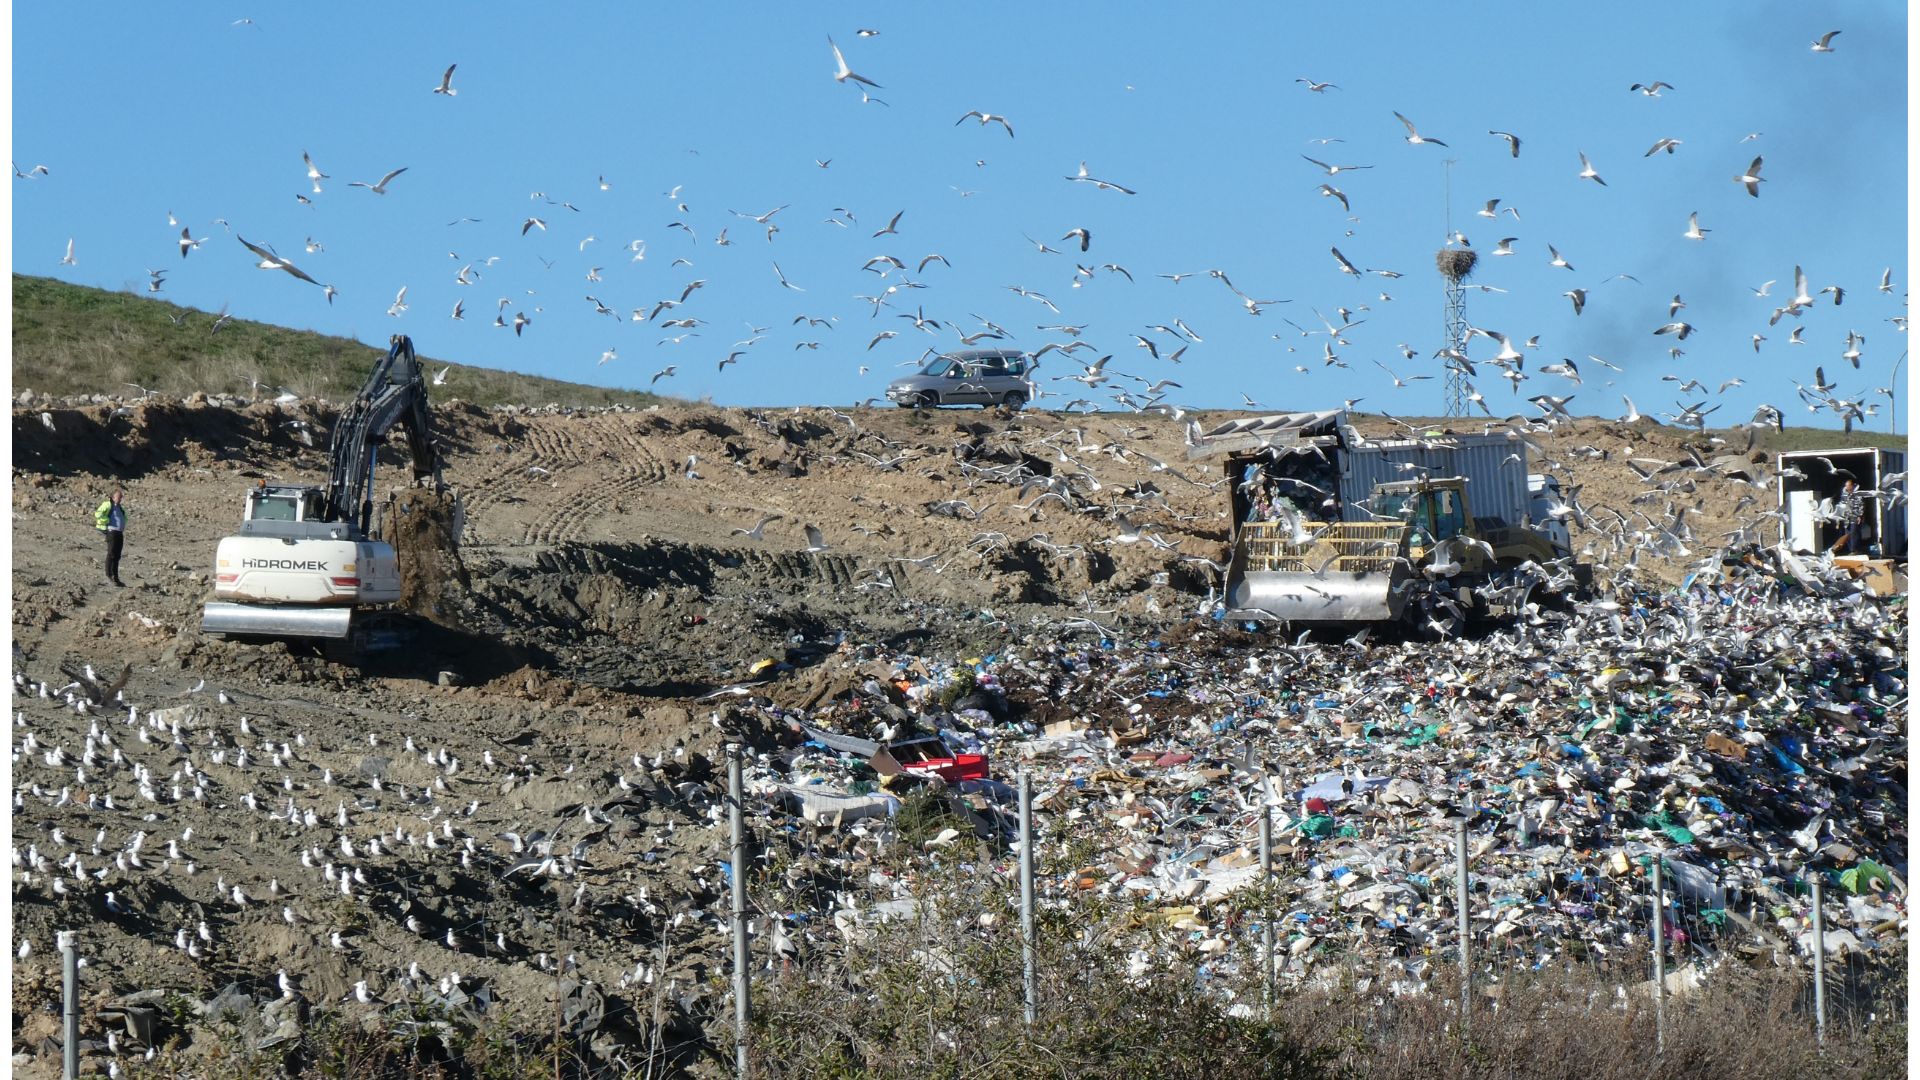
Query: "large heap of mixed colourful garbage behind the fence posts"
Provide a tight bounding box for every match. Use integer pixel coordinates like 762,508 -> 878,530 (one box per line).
737,561 -> 1908,986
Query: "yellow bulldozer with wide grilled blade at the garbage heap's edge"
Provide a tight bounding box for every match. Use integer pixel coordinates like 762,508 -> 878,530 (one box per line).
1225,477 -> 1590,636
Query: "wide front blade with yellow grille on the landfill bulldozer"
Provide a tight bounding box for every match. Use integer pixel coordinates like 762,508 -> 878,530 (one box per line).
1227,521 -> 1411,623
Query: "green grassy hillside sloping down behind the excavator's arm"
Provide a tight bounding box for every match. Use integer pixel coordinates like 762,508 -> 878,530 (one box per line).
13,275 -> 659,405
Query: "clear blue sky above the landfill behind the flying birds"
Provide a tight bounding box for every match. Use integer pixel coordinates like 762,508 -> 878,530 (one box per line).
12,2 -> 1908,430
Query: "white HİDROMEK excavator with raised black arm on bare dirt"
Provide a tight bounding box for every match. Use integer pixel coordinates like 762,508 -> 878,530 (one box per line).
200,334 -> 459,655
